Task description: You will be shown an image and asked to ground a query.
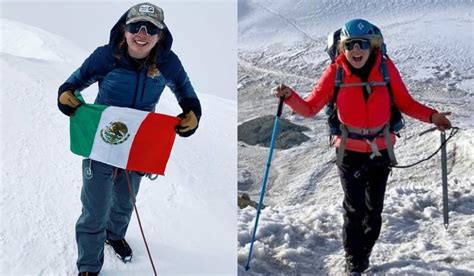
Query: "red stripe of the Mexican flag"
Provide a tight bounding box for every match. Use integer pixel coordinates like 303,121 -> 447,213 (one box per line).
127,113 -> 179,175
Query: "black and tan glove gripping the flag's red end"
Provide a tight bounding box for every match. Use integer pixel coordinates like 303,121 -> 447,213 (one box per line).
175,98 -> 201,137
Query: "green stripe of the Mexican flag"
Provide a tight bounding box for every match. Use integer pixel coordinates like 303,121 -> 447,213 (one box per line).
70,104 -> 107,157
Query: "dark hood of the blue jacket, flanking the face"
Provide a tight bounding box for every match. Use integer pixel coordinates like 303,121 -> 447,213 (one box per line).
109,10 -> 173,63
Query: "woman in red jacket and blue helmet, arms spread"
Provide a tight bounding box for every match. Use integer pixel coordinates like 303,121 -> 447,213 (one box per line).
273,19 -> 451,272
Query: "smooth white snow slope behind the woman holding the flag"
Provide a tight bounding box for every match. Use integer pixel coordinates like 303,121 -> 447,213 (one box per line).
0,19 -> 237,275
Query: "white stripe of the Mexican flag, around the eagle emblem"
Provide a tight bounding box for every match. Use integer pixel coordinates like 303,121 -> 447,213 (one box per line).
90,106 -> 148,168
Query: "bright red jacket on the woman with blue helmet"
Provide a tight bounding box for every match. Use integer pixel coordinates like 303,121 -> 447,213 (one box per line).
285,54 -> 437,152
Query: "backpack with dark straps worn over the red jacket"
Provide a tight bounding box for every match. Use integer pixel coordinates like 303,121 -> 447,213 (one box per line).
325,26 -> 405,165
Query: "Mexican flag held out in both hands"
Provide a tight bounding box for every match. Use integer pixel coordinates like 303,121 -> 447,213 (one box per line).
70,103 -> 180,175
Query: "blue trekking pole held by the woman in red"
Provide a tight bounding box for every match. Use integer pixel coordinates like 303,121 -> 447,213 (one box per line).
245,97 -> 284,270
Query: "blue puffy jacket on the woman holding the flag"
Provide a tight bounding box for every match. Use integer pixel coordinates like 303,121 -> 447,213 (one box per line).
58,9 -> 201,118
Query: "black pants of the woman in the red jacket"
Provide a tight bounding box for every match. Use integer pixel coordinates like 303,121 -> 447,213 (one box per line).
338,150 -> 390,263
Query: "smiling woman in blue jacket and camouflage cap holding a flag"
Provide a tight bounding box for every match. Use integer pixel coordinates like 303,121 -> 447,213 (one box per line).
58,3 -> 201,275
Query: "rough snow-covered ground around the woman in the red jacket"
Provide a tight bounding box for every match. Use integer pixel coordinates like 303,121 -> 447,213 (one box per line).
238,0 -> 474,275
